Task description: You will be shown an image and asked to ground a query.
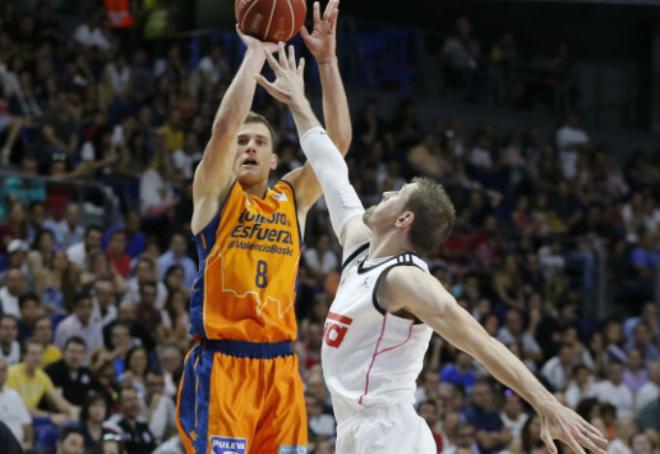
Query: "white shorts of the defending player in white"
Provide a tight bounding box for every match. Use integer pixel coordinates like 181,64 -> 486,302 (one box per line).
335,404 -> 438,454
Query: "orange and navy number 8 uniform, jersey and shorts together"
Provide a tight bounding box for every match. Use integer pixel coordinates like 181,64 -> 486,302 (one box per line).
177,181 -> 307,454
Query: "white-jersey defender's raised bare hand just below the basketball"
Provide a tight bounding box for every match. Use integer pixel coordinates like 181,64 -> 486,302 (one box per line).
257,43 -> 305,107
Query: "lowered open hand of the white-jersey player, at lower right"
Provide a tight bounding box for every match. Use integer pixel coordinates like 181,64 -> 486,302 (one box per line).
540,403 -> 607,454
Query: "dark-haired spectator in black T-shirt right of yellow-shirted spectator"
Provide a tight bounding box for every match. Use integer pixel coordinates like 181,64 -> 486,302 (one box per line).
45,336 -> 99,407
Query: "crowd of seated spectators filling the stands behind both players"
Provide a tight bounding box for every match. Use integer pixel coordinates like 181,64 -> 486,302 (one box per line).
0,2 -> 660,454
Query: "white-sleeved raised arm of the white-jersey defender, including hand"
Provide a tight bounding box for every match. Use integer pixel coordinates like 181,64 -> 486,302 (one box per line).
259,45 -> 369,255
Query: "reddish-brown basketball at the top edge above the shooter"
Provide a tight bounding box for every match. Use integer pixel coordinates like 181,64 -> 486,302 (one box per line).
234,0 -> 307,43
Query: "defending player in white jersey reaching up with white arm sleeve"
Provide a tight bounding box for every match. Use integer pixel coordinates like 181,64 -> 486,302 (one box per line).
259,44 -> 607,454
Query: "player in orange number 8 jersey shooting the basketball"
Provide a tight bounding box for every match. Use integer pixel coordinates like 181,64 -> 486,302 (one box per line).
177,0 -> 352,454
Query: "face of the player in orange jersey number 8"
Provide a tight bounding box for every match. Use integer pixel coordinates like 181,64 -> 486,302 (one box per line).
234,123 -> 277,186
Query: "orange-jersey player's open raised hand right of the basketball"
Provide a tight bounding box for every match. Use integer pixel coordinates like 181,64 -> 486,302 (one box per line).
300,0 -> 339,63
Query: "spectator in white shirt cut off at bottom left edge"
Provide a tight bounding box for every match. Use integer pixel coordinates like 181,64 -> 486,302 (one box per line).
0,355 -> 33,451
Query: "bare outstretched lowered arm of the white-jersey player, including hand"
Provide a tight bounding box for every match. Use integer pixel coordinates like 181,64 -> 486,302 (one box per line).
378,267 -> 607,454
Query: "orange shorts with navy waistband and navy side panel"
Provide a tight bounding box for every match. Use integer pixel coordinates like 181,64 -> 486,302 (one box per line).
177,340 -> 307,454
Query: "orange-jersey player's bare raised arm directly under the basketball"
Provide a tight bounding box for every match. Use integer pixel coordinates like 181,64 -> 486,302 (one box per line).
191,26 -> 276,233
